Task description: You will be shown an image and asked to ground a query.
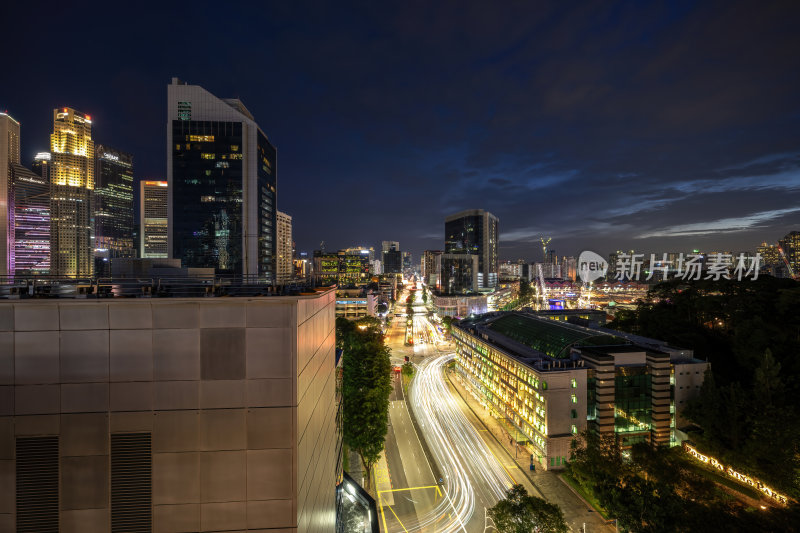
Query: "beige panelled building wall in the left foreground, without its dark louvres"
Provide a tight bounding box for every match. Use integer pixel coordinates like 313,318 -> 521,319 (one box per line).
0,291 -> 337,532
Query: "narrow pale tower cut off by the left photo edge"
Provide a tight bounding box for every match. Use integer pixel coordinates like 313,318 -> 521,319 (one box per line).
0,113 -> 19,277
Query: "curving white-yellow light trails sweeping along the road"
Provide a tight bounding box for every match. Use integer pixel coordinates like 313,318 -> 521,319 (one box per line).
408,354 -> 512,532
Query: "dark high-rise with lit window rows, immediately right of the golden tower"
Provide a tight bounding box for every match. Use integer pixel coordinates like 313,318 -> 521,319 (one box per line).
92,144 -> 136,275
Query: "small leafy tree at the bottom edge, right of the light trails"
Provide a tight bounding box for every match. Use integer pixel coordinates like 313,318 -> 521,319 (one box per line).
489,485 -> 569,533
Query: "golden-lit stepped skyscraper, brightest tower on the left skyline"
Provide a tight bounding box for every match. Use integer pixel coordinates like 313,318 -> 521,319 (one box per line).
50,107 -> 95,277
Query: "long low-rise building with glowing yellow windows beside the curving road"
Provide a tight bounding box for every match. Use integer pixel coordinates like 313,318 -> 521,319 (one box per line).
452,310 -> 708,469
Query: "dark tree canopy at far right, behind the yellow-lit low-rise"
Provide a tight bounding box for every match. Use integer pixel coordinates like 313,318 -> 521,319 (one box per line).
610,276 -> 800,498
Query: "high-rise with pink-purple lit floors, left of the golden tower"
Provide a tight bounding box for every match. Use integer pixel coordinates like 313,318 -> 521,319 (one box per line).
9,164 -> 50,276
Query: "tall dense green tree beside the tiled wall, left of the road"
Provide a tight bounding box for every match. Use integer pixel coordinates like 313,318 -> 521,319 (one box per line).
336,317 -> 392,488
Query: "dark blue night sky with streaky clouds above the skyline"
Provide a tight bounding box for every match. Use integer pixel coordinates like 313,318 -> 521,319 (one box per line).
0,1 -> 800,261
